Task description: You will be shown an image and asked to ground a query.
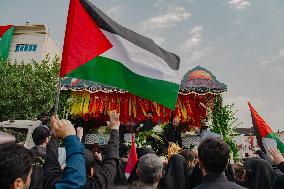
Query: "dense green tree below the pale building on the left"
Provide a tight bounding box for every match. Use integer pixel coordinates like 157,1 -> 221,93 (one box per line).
0,56 -> 60,121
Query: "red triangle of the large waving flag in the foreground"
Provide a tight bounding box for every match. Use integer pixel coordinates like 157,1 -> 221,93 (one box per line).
60,0 -> 112,77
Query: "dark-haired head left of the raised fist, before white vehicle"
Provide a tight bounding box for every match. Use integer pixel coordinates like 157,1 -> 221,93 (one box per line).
32,125 -> 50,145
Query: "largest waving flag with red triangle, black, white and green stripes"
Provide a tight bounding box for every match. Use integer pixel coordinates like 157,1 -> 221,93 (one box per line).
60,0 -> 181,109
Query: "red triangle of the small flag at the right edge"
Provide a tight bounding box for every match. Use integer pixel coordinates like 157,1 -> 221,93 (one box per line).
248,102 -> 272,137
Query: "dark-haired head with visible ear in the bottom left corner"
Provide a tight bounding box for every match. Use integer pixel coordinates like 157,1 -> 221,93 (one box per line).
0,144 -> 34,189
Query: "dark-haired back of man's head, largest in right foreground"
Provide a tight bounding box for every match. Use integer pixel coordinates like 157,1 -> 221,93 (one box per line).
198,138 -> 230,175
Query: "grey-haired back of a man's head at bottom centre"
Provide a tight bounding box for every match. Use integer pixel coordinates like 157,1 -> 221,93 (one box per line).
137,154 -> 163,185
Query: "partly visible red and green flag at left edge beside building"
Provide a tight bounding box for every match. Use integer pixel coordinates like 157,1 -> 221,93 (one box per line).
0,25 -> 14,59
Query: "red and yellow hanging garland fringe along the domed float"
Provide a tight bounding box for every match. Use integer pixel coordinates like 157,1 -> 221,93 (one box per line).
66,91 -> 212,127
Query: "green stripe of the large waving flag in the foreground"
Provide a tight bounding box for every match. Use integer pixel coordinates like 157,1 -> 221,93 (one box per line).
67,57 -> 179,109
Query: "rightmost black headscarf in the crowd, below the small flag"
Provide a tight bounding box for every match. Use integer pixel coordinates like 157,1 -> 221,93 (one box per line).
244,158 -> 275,189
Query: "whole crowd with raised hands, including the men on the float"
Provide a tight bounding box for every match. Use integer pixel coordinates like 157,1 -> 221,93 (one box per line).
0,111 -> 284,189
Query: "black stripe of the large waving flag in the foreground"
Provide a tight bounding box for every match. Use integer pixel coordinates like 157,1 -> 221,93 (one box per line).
81,0 -> 180,70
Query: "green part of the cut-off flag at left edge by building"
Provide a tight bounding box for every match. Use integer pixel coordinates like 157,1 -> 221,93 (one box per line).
0,27 -> 14,59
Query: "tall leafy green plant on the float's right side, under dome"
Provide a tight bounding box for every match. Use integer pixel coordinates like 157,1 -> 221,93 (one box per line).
210,96 -> 241,159
